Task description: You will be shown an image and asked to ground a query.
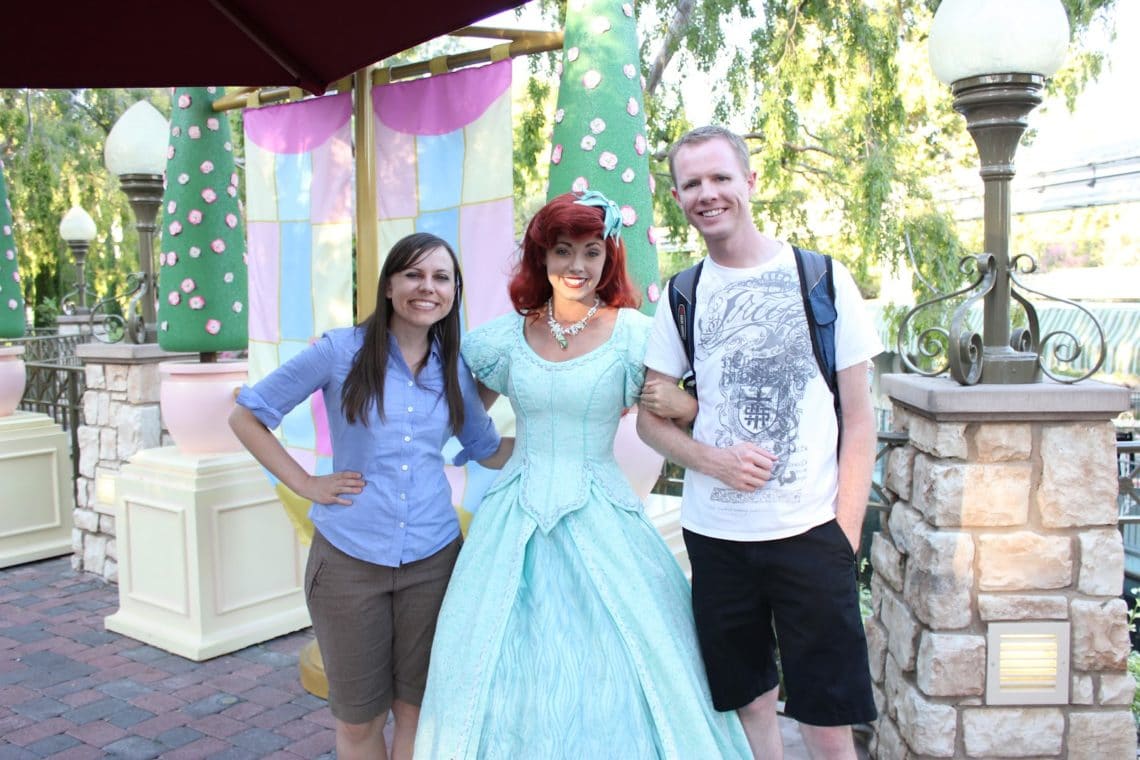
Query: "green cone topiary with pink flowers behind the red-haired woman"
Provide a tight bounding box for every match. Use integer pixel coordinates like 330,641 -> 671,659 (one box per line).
547,0 -> 660,314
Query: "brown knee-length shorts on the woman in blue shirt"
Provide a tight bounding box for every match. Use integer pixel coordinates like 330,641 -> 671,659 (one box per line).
304,532 -> 463,724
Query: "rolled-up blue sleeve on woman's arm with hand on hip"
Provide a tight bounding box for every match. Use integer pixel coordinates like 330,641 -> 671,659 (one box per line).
237,333 -> 336,430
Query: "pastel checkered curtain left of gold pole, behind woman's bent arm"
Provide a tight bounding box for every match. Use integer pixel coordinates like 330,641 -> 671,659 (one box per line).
244,93 -> 353,537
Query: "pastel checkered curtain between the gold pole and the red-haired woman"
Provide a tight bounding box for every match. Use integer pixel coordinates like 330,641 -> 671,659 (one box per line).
372,60 -> 515,523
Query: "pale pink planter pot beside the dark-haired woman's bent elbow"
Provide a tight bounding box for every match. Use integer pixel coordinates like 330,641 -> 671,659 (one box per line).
158,361 -> 249,453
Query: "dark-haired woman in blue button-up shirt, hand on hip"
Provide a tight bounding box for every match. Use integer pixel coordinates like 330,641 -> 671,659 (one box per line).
230,232 -> 512,759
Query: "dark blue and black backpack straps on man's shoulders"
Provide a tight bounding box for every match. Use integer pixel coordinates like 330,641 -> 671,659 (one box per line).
666,246 -> 842,430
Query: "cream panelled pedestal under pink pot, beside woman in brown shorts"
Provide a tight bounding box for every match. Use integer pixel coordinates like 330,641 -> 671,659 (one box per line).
106,447 -> 309,660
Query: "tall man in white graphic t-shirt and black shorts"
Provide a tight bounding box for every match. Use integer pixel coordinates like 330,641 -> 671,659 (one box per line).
637,126 -> 882,760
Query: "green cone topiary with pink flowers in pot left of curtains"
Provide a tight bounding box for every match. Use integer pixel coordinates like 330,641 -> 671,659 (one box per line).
158,87 -> 249,361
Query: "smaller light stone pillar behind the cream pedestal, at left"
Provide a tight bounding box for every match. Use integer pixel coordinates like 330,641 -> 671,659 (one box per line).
72,343 -> 194,581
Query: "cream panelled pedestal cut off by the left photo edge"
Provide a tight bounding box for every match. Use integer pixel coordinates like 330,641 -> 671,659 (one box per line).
0,411 -> 75,567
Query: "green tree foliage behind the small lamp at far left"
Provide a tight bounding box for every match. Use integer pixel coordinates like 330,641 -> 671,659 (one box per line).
0,90 -> 169,322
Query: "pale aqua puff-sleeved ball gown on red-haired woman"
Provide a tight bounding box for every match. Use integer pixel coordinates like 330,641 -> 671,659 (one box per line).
415,309 -> 751,760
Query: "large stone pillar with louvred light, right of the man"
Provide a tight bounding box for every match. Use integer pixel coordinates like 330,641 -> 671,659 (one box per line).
866,375 -> 1137,760
